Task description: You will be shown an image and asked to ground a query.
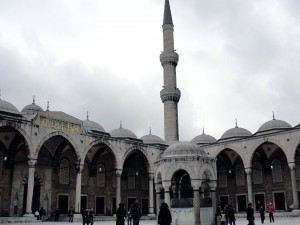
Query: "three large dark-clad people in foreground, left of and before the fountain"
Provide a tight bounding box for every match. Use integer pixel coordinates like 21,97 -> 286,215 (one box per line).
116,199 -> 172,225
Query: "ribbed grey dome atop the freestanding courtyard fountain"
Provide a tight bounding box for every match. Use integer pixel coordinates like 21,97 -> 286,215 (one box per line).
163,141 -> 206,157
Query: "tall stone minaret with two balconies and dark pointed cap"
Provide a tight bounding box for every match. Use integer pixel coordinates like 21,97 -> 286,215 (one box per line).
160,0 -> 181,143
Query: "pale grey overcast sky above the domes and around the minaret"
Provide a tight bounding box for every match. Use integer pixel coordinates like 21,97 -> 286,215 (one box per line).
0,0 -> 300,140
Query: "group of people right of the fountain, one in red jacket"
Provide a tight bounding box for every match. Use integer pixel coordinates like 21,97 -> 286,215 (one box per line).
216,202 -> 275,225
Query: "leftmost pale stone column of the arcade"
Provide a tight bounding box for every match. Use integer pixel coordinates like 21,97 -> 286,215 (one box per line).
24,159 -> 37,217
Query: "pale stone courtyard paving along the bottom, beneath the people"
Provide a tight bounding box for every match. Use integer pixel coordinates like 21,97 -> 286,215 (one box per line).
2,217 -> 300,225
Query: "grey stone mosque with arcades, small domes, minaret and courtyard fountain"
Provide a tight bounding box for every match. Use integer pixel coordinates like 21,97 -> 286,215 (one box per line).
0,0 -> 300,224
